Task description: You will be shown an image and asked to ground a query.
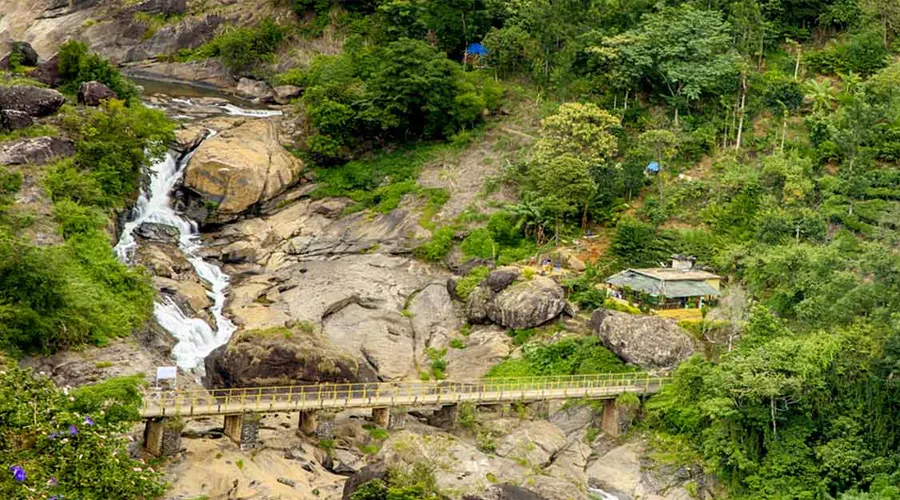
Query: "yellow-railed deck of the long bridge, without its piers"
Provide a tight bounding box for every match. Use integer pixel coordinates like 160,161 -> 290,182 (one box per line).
141,372 -> 670,418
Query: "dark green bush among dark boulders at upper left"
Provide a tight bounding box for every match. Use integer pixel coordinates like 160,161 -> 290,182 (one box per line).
59,40 -> 137,101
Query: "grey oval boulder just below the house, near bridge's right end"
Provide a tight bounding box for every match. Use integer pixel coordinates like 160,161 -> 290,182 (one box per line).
591,309 -> 694,369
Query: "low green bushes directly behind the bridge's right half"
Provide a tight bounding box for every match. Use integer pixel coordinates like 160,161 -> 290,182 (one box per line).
487,337 -> 634,377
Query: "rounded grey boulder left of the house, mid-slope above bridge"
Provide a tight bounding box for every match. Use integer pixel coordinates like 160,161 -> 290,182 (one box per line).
487,276 -> 566,329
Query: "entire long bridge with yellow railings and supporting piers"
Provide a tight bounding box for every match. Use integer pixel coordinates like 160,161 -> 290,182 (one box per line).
141,372 -> 670,455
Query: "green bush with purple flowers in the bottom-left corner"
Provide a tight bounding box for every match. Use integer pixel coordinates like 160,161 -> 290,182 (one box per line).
0,366 -> 165,500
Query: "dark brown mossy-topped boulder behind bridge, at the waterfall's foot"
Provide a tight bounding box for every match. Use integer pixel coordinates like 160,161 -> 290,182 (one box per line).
205,324 -> 376,388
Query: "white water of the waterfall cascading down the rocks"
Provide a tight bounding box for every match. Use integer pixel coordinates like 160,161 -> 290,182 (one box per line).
114,132 -> 236,369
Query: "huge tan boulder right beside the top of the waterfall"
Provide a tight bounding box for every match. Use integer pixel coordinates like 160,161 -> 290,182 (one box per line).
184,120 -> 303,222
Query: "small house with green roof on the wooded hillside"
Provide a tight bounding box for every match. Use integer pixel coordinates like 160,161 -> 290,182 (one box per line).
605,255 -> 722,309
